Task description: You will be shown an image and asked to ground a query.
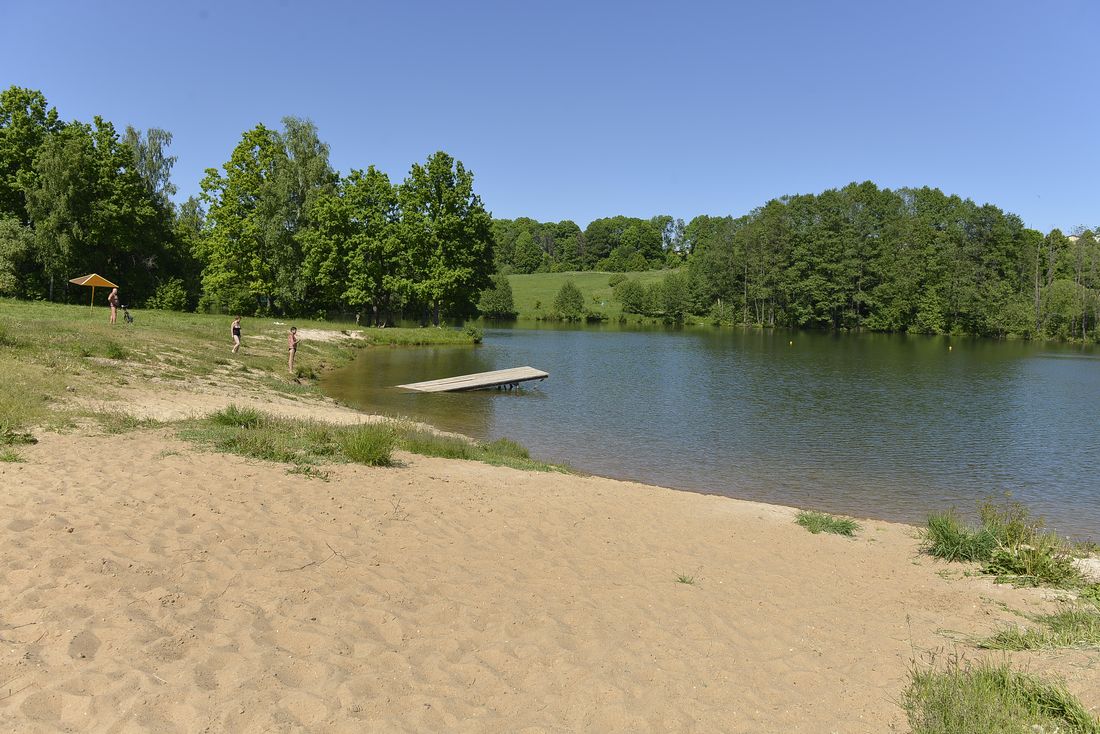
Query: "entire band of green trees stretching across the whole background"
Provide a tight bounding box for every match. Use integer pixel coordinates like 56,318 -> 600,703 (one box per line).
0,87 -> 1100,341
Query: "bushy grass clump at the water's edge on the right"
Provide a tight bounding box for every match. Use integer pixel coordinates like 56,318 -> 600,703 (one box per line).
923,502 -> 1081,587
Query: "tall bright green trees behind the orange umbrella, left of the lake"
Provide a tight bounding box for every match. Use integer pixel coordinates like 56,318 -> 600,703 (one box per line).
0,87 -> 494,324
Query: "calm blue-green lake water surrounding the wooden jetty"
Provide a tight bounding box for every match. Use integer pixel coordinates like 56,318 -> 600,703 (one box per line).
323,327 -> 1100,539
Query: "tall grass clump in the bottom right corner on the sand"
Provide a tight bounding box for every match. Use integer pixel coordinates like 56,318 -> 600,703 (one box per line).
902,657 -> 1100,734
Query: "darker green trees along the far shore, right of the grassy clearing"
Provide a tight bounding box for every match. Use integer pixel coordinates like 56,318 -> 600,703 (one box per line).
494,182 -> 1100,340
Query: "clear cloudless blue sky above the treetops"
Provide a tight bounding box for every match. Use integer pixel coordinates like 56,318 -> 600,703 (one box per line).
0,0 -> 1100,231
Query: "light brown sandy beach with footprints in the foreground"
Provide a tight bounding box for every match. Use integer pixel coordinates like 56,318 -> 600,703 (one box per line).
0,382 -> 1100,733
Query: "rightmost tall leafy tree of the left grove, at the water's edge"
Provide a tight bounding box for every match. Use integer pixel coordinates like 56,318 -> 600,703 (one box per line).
398,151 -> 493,326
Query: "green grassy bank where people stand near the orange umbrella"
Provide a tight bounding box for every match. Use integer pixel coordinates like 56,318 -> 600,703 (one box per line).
0,299 -> 475,431
